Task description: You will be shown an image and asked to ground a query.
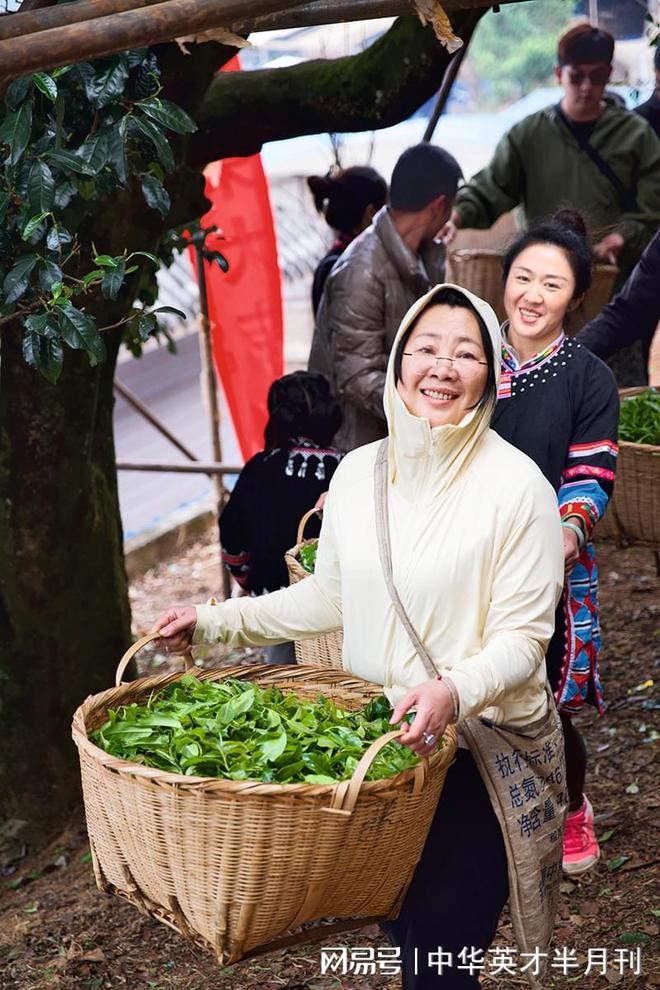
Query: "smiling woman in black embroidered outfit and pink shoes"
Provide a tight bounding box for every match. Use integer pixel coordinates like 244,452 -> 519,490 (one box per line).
493,210 -> 619,874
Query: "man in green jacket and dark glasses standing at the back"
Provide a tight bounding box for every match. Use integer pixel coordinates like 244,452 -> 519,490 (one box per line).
444,24 -> 660,283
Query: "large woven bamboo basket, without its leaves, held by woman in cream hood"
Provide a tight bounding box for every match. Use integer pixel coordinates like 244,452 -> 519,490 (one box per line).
73,635 -> 456,964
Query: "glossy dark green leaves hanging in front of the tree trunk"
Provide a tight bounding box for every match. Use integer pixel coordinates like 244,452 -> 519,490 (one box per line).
0,49 -> 196,383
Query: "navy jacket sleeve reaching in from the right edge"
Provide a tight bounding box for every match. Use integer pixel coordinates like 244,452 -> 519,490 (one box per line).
575,230 -> 660,376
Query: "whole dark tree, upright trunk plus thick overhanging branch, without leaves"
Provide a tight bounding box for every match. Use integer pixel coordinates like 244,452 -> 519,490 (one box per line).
0,13 -> 476,840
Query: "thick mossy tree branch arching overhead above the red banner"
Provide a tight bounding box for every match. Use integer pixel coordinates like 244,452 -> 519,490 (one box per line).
187,10 -> 483,167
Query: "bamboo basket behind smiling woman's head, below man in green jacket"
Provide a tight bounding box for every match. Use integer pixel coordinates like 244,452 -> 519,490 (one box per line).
447,248 -> 619,336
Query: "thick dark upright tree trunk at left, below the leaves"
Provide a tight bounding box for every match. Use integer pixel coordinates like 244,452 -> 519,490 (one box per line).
0,326 -> 130,831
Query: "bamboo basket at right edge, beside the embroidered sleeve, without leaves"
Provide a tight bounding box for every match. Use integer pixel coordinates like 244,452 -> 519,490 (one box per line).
594,387 -> 660,550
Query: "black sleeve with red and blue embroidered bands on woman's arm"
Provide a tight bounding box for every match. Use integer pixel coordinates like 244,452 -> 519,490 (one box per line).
558,359 -> 619,538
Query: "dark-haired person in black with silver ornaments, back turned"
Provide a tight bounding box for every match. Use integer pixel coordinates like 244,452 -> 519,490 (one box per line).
219,371 -> 341,663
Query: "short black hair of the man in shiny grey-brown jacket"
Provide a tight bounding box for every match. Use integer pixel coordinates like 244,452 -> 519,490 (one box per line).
390,144 -> 463,213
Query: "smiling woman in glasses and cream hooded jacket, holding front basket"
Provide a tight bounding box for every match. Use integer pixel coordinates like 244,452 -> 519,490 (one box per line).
154,286 -> 564,990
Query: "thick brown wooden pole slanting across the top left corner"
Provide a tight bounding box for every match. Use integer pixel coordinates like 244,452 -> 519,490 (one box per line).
0,0 -> 314,80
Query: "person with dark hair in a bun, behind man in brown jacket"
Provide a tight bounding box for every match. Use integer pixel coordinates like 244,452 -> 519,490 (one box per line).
307,165 -> 387,316
